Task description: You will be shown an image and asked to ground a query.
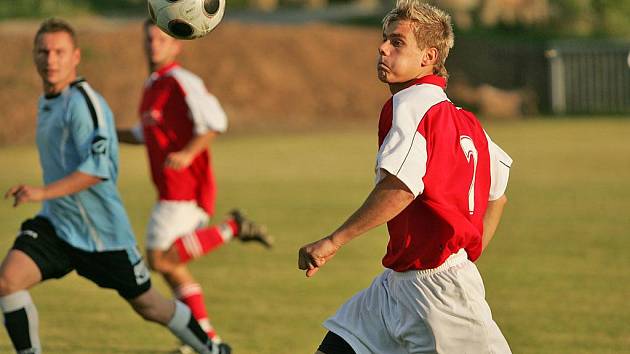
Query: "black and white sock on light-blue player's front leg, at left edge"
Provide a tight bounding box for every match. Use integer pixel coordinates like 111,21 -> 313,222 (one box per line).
0,290 -> 42,354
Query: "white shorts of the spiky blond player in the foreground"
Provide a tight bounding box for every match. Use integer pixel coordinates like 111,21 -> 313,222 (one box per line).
324,249 -> 511,354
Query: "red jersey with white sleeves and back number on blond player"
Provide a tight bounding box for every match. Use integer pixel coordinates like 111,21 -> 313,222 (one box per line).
376,75 -> 512,272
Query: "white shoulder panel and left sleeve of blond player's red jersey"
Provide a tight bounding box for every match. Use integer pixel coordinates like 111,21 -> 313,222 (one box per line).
376,84 -> 448,197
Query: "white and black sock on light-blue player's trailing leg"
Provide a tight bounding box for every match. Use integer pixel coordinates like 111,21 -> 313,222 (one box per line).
167,300 -> 212,354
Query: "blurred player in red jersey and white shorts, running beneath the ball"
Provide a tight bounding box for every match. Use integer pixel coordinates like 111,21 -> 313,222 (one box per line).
118,20 -> 271,352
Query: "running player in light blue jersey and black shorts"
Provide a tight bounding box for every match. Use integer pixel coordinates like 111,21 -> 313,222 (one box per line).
0,19 -> 230,354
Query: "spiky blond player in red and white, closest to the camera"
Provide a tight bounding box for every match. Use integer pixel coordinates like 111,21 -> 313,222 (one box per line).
298,0 -> 512,354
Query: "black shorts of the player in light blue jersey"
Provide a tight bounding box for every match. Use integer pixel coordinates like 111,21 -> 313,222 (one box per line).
13,216 -> 151,299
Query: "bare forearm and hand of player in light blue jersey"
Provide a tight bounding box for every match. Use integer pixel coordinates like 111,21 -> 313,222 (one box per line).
4,171 -> 101,207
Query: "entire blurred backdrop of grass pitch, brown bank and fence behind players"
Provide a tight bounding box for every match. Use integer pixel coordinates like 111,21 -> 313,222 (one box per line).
0,0 -> 630,354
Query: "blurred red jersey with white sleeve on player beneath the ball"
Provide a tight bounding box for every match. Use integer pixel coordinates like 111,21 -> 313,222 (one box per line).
134,63 -> 227,215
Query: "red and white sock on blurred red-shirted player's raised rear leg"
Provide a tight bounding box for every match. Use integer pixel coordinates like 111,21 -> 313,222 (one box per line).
175,219 -> 238,263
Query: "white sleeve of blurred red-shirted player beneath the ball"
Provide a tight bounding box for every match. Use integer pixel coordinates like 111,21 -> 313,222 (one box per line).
167,67 -> 227,135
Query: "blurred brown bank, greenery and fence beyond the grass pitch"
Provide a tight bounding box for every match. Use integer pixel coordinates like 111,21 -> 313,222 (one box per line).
0,0 -> 630,144
